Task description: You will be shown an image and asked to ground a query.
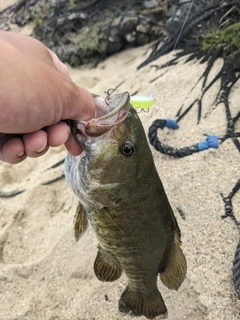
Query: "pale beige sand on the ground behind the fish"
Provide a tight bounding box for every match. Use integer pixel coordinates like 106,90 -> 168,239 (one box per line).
0,2 -> 240,320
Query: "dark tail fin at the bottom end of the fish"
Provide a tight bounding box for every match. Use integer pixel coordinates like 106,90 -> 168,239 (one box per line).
118,286 -> 167,319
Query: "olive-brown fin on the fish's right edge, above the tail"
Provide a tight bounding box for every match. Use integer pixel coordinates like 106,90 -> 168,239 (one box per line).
160,230 -> 187,290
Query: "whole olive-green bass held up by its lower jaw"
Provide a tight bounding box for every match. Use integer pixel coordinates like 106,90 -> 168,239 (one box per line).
64,92 -> 187,319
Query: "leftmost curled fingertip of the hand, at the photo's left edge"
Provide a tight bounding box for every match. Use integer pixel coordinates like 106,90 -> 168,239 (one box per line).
0,137 -> 27,164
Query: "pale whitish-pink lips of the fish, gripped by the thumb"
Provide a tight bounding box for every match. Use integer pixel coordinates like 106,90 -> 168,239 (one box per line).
75,91 -> 130,137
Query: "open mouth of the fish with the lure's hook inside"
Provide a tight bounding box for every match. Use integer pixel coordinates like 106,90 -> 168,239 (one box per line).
75,92 -> 130,137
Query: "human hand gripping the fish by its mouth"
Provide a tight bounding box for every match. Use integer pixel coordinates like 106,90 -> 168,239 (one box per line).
0,31 -> 95,164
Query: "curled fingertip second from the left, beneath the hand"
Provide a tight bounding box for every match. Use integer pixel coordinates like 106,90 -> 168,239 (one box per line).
23,130 -> 48,158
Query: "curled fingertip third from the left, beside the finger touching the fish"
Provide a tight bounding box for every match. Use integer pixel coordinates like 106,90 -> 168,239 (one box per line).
46,122 -> 71,147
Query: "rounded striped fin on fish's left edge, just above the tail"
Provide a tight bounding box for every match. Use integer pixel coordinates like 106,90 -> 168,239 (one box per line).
94,246 -> 122,281
